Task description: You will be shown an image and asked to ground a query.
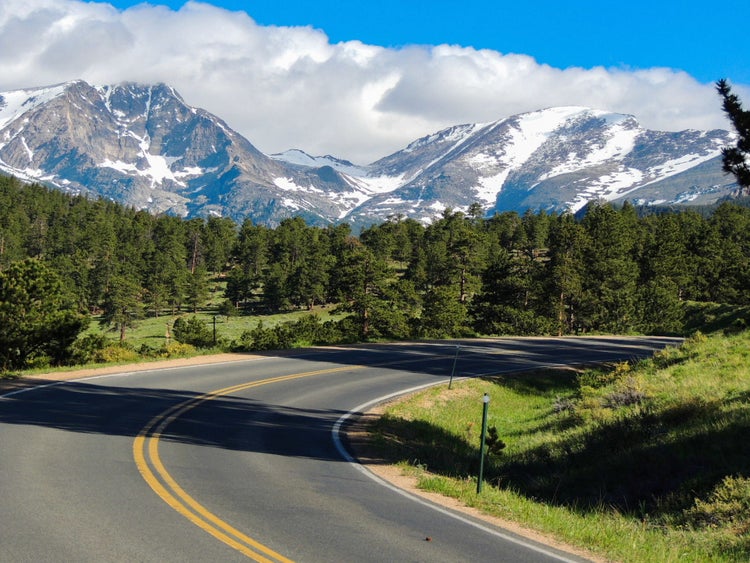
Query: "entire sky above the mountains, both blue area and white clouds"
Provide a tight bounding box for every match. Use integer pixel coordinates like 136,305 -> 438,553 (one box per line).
0,0 -> 750,164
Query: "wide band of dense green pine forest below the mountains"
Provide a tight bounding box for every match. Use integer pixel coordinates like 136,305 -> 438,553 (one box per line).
0,177 -> 750,368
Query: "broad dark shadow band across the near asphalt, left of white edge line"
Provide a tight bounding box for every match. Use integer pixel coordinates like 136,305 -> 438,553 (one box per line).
0,381 -> 358,461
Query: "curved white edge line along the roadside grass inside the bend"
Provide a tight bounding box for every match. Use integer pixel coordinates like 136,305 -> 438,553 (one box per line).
331,375 -> 582,563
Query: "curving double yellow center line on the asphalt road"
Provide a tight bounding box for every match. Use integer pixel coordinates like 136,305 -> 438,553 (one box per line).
133,366 -> 364,563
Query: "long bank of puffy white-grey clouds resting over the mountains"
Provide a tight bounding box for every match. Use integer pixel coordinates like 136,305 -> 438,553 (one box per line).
0,0 -> 745,163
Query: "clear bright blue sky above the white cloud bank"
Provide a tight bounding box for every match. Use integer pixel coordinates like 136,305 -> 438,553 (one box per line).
107,0 -> 750,84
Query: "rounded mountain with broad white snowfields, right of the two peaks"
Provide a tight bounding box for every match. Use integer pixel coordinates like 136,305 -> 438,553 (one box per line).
322,107 -> 736,223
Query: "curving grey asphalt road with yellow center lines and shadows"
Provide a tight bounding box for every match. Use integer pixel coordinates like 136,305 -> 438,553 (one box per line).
0,338 -> 674,562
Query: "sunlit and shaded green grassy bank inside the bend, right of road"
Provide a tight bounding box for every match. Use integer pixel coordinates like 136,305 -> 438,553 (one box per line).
372,332 -> 750,562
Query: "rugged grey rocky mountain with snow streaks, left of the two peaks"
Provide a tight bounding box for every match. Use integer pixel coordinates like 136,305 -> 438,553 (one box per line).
0,81 -> 360,224
